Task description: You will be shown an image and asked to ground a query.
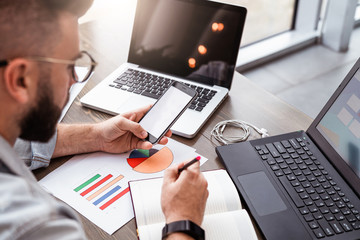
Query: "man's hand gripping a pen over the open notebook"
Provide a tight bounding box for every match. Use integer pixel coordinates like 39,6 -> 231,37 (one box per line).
161,162 -> 209,226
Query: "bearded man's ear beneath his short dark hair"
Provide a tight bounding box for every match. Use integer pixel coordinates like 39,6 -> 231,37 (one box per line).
4,58 -> 36,103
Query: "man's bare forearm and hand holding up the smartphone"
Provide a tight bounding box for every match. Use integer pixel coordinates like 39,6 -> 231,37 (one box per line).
52,105 -> 171,158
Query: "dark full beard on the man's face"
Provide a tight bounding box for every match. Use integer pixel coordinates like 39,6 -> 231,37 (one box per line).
19,76 -> 61,142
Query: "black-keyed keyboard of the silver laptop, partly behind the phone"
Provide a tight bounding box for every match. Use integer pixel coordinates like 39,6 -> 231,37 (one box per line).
109,69 -> 216,112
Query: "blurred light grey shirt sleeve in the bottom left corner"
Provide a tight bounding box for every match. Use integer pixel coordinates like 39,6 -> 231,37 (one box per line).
0,173 -> 86,240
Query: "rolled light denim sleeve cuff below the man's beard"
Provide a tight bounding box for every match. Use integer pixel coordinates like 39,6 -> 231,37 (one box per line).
14,131 -> 57,170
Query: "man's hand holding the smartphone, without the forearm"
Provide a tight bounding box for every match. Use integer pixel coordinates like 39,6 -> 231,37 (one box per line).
96,105 -> 171,153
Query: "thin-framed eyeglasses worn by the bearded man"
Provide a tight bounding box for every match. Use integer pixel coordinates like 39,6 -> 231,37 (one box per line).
0,51 -> 97,82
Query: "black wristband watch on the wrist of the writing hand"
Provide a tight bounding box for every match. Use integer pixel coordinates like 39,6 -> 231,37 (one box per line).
161,220 -> 205,240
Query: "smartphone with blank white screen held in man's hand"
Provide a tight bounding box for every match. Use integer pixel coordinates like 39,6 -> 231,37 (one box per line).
139,82 -> 198,144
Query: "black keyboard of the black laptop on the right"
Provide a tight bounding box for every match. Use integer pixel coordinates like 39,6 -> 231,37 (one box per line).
255,138 -> 360,238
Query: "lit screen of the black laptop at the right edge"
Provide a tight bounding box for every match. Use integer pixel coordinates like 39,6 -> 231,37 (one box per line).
316,70 -> 360,177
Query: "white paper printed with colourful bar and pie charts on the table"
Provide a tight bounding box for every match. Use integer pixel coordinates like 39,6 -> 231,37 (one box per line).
39,138 -> 207,234
